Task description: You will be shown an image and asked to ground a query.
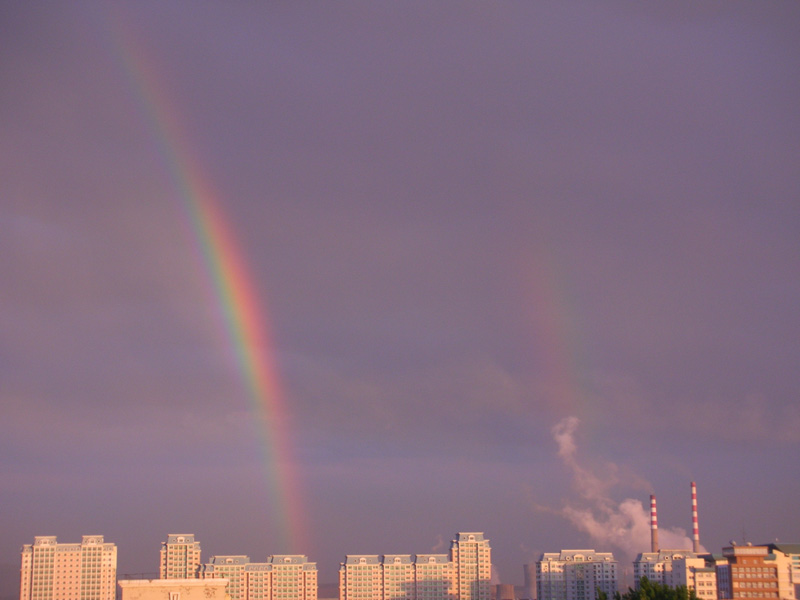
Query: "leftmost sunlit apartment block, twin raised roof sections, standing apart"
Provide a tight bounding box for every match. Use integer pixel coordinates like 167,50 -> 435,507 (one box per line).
19,535 -> 117,600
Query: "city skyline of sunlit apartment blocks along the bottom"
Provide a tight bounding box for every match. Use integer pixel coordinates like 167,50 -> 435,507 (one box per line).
14,528 -> 800,600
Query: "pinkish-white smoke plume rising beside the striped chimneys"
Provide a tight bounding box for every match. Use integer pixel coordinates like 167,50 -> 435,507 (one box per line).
552,417 -> 692,560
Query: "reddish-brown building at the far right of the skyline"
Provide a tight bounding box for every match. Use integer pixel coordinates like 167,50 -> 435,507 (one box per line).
717,544 -> 796,600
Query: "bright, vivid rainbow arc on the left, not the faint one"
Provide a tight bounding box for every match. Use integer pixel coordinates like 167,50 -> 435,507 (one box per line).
112,18 -> 307,553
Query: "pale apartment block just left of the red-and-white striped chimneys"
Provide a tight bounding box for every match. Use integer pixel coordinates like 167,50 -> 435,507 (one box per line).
536,550 -> 619,600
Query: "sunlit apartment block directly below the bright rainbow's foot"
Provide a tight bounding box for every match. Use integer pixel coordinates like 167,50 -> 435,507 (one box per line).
202,554 -> 318,600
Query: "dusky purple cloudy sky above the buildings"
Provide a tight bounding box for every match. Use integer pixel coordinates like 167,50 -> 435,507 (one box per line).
0,1 -> 800,595
